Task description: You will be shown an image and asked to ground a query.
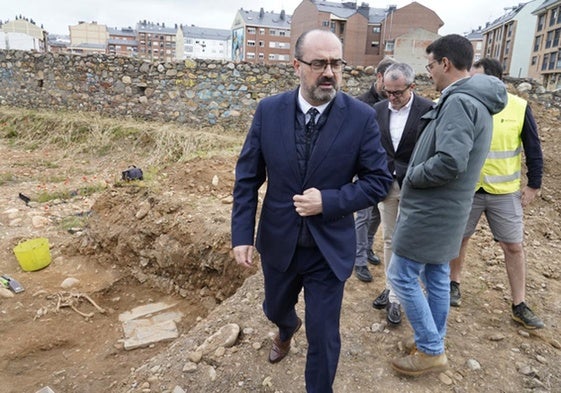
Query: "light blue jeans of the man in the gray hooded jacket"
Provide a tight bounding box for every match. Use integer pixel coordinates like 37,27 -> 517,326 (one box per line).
388,253 -> 450,355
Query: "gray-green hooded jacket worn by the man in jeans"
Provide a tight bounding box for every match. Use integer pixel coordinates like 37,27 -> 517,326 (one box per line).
392,74 -> 507,263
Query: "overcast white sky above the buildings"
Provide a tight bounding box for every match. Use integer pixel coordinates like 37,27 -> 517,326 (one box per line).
4,0 -> 542,35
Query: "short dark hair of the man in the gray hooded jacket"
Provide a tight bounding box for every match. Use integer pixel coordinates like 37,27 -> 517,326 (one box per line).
426,34 -> 473,71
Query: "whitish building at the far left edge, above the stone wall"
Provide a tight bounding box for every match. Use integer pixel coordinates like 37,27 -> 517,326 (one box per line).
0,17 -> 48,52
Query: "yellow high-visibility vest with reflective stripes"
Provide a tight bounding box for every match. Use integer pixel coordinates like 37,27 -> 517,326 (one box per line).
475,93 -> 528,194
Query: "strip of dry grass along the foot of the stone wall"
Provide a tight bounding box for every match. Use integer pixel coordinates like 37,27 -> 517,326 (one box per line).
0,107 -> 243,166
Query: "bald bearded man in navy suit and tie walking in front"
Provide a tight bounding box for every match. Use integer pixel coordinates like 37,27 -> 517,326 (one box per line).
232,30 -> 392,393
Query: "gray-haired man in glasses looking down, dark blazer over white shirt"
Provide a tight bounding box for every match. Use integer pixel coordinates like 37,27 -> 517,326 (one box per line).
372,63 -> 434,325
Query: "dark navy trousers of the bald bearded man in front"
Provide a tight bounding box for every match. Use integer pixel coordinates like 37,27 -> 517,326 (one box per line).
263,247 -> 345,393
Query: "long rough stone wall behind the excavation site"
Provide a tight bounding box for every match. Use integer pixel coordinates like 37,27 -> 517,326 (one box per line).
0,50 -> 374,132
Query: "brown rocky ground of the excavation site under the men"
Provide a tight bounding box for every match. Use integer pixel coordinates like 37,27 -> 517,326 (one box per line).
0,83 -> 561,393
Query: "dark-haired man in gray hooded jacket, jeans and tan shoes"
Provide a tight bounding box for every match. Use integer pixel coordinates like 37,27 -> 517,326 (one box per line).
388,34 -> 507,375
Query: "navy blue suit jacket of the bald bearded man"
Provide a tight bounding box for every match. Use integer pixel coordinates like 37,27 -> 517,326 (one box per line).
232,90 -> 392,280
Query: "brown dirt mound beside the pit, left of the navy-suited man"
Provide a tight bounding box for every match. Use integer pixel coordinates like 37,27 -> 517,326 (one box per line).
76,157 -> 250,304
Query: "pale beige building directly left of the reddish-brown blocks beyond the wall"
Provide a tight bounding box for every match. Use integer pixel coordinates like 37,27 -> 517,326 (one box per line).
68,21 -> 109,54
